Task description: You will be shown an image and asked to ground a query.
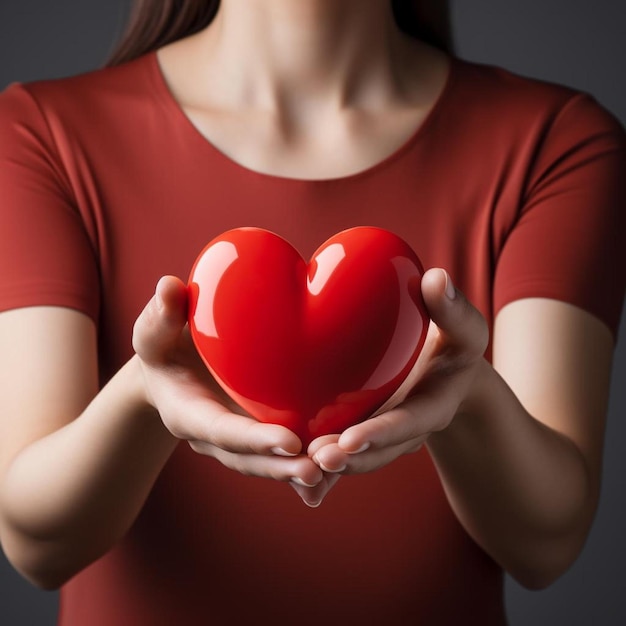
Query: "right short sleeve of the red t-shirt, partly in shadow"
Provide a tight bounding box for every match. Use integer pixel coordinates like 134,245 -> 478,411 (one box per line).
494,94 -> 626,337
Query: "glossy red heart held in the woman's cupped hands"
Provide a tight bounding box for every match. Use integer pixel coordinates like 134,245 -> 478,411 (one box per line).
189,227 -> 428,446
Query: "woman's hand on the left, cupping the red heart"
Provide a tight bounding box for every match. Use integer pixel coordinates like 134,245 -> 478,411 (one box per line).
133,276 -> 324,487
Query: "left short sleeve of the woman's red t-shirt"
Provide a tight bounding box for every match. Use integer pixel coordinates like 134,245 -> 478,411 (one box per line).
0,83 -> 100,321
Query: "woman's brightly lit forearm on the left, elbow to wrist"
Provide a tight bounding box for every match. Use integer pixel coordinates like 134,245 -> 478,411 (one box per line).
0,357 -> 177,587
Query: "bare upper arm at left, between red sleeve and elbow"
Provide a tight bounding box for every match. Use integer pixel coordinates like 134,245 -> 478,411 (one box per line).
0,306 -> 98,473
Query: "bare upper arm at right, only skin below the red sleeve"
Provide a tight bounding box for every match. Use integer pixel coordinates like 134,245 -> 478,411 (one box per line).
493,298 -> 614,484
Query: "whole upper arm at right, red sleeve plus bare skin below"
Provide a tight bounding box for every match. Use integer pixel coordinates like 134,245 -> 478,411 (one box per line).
493,95 -> 626,484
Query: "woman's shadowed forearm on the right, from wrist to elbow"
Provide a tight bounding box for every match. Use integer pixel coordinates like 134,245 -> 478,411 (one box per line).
427,361 -> 599,587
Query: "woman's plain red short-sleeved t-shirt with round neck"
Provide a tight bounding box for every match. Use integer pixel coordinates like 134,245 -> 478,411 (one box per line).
0,53 -> 626,626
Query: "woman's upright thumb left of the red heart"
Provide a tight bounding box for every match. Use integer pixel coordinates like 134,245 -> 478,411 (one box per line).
133,276 -> 187,363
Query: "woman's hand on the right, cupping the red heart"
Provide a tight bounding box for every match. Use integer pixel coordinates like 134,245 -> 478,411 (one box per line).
294,269 -> 489,506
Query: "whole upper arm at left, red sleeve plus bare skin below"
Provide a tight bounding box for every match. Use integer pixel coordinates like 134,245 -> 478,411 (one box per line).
0,84 -> 100,472
